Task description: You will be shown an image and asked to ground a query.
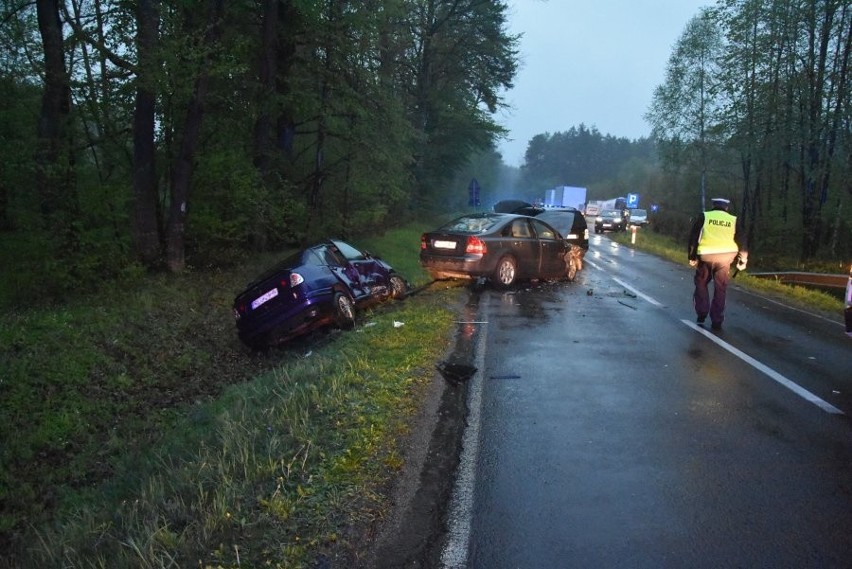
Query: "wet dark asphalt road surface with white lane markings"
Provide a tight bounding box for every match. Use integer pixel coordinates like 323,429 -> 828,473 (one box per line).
443,236 -> 852,569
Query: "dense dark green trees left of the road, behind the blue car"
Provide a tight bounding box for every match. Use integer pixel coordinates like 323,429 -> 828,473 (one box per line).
0,0 -> 517,302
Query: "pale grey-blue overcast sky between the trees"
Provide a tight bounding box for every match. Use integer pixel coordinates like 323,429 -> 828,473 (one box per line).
496,0 -> 714,166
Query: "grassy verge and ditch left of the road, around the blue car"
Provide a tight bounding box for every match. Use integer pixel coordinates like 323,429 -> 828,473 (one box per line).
0,223 -> 457,568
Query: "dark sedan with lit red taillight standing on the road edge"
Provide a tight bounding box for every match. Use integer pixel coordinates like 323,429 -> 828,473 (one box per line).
420,213 -> 570,287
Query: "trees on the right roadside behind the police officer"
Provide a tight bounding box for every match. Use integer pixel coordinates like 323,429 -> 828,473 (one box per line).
648,0 -> 852,261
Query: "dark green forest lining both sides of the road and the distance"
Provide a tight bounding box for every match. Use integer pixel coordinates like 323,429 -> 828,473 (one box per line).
0,0 -> 852,310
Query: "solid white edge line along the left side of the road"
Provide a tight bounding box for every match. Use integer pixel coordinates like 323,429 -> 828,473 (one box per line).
441,295 -> 489,569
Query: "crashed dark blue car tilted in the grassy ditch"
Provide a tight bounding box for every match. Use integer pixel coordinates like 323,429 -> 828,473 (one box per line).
234,240 -> 408,349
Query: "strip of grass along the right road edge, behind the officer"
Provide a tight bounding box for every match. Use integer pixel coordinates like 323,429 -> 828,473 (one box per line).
609,229 -> 843,318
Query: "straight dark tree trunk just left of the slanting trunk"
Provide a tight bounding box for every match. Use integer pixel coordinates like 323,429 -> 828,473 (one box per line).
132,0 -> 160,267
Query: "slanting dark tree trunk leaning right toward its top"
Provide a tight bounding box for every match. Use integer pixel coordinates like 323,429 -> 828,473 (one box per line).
166,0 -> 224,273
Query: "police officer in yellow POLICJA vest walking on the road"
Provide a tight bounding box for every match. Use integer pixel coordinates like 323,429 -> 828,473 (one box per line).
687,198 -> 748,330
